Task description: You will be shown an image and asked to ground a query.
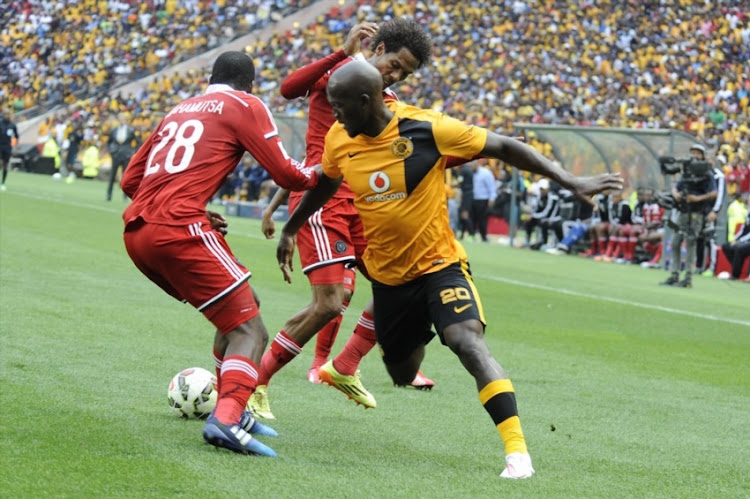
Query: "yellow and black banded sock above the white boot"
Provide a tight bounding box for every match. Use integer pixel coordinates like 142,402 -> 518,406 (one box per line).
479,379 -> 528,454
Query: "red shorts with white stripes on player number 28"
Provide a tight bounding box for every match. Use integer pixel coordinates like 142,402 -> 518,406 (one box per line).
124,221 -> 259,333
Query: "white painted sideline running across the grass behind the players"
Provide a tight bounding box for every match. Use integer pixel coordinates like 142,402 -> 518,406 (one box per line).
8,192 -> 750,327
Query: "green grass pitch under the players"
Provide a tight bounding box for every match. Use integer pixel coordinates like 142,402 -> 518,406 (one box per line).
0,172 -> 750,498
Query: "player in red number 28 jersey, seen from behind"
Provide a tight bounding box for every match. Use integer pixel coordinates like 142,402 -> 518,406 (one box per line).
121,52 -> 318,456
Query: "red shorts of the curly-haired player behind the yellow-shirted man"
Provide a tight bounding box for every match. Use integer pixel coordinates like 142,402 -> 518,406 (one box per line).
289,197 -> 367,285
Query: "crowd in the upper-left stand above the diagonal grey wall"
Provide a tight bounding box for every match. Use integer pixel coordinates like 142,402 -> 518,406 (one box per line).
0,0 -> 314,116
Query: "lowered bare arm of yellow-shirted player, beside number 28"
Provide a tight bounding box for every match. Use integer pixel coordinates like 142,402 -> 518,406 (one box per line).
276,173 -> 343,282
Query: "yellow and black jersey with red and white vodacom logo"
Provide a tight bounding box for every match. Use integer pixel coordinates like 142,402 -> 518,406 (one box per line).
323,102 -> 487,285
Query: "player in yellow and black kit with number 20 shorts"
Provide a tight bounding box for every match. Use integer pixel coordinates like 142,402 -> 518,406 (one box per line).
277,62 -> 622,478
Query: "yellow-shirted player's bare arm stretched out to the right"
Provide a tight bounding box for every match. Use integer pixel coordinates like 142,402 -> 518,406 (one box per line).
480,131 -> 623,206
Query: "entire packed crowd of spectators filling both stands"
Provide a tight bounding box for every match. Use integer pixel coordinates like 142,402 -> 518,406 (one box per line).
5,0 -> 750,282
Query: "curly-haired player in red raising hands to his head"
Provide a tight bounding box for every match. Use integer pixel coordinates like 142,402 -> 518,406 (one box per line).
250,19 -> 434,418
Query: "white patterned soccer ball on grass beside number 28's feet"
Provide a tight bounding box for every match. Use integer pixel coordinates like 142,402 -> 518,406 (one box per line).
167,367 -> 218,419
